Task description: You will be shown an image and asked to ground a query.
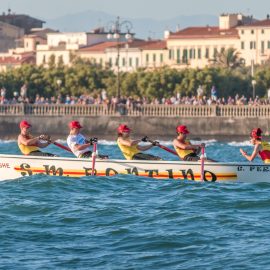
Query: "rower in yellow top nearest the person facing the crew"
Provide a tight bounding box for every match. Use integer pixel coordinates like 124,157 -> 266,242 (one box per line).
173,126 -> 205,161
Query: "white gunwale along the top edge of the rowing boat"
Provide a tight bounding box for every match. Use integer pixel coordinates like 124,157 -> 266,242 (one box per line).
0,154 -> 270,167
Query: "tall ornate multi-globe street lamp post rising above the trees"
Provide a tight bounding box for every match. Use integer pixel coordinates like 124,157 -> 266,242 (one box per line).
107,17 -> 132,98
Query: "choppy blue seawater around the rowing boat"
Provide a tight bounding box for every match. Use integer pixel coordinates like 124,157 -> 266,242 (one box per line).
0,141 -> 270,269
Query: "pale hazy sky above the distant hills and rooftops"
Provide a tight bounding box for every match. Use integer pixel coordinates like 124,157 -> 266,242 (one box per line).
0,0 -> 270,20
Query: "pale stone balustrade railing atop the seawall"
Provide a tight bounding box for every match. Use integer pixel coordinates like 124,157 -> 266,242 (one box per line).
0,104 -> 270,118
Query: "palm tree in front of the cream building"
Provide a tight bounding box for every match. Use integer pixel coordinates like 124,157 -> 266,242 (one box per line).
209,48 -> 244,69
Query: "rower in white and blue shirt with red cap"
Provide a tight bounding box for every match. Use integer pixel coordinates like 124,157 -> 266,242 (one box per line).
67,121 -> 108,159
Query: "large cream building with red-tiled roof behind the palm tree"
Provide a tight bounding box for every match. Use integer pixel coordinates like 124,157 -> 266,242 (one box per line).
164,14 -> 270,69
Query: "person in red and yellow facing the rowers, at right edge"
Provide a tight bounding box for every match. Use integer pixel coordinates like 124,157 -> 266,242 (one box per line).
240,128 -> 270,164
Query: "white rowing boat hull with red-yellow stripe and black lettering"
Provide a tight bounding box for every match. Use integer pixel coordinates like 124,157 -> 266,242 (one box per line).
0,155 -> 270,182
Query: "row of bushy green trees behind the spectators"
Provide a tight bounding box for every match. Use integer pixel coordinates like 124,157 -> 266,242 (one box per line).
0,59 -> 270,99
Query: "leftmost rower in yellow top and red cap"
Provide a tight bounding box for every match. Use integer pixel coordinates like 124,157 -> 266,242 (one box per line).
18,120 -> 56,157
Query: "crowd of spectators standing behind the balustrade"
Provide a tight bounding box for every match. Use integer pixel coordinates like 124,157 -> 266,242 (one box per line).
0,85 -> 270,106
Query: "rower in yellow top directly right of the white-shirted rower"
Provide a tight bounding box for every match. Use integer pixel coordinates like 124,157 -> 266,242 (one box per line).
117,124 -> 161,160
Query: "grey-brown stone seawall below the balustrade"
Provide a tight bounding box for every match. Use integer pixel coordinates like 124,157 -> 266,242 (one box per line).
0,116 -> 270,140
